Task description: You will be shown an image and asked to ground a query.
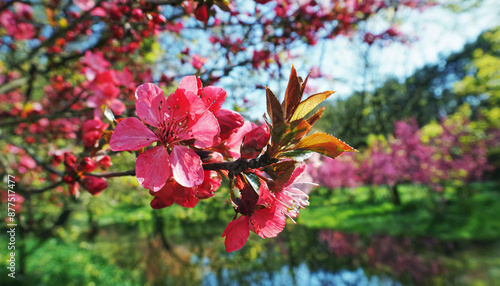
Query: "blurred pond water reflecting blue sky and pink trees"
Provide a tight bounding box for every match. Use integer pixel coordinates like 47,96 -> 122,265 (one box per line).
137,225 -> 500,285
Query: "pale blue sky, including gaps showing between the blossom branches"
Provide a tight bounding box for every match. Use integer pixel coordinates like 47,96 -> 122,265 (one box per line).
156,0 -> 500,119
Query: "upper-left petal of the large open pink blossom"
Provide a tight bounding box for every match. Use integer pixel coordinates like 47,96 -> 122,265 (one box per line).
135,83 -> 166,127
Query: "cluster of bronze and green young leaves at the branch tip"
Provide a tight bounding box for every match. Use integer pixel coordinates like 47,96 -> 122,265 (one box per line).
265,66 -> 356,183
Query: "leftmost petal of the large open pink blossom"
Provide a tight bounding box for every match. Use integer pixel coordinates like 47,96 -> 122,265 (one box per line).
109,117 -> 159,151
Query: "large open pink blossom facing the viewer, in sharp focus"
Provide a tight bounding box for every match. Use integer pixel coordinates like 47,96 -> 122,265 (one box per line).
110,76 -> 219,192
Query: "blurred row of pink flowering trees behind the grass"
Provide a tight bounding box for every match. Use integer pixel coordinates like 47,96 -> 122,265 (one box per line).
308,119 -> 495,191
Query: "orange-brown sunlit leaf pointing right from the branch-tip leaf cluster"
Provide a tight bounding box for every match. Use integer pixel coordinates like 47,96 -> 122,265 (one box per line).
294,133 -> 357,158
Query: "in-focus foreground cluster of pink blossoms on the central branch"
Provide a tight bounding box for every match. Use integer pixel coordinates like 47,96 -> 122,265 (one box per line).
110,76 -> 314,251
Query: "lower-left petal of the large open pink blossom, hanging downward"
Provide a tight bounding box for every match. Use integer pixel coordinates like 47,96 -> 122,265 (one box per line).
135,145 -> 172,192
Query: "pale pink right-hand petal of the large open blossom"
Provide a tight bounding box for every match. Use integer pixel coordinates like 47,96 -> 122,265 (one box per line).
186,110 -> 219,148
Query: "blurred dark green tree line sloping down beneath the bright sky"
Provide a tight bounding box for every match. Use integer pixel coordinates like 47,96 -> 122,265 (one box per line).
317,28 -> 500,148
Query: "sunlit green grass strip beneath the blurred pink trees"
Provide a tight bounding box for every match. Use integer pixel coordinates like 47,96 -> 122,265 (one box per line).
300,183 -> 500,240
